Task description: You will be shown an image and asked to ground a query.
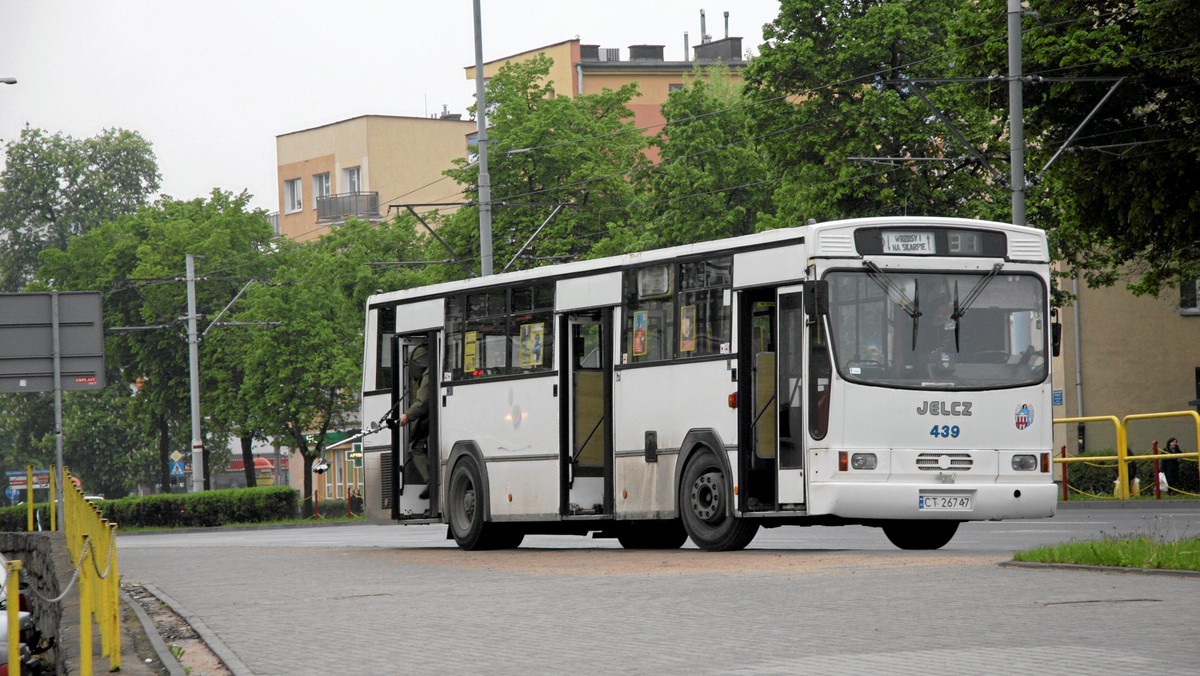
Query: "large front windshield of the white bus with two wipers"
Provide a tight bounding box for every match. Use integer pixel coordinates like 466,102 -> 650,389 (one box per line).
826,264 -> 1048,390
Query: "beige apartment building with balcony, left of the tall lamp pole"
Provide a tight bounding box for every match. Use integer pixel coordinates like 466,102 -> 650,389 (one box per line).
275,112 -> 475,241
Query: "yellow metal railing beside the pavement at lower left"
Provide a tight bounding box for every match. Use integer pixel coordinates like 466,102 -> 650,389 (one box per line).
62,467 -> 121,676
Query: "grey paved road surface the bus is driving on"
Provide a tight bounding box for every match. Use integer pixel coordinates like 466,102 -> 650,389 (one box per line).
120,507 -> 1200,676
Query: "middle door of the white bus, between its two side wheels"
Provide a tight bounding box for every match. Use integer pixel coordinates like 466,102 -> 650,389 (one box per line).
560,311 -> 612,518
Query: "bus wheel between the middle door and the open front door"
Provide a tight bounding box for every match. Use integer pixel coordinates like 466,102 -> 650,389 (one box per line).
679,449 -> 758,551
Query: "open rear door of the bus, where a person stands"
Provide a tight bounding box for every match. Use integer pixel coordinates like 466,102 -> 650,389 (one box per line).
390,331 -> 440,520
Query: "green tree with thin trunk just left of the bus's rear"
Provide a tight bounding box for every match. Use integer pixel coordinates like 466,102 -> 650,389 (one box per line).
238,219 -> 430,496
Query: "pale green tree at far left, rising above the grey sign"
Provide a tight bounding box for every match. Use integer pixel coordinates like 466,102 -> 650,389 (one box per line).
0,126 -> 160,292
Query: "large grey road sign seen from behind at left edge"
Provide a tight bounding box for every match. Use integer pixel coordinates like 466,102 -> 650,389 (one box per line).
0,292 -> 104,391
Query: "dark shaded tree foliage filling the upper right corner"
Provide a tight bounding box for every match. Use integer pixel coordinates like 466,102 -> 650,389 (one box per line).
1012,0 -> 1200,294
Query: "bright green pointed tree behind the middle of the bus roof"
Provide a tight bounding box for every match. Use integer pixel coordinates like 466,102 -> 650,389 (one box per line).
636,66 -> 776,249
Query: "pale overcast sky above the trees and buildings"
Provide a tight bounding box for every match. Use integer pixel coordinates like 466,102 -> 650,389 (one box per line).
0,0 -> 779,211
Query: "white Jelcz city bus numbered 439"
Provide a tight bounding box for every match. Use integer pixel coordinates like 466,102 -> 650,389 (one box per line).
362,217 -> 1057,550
